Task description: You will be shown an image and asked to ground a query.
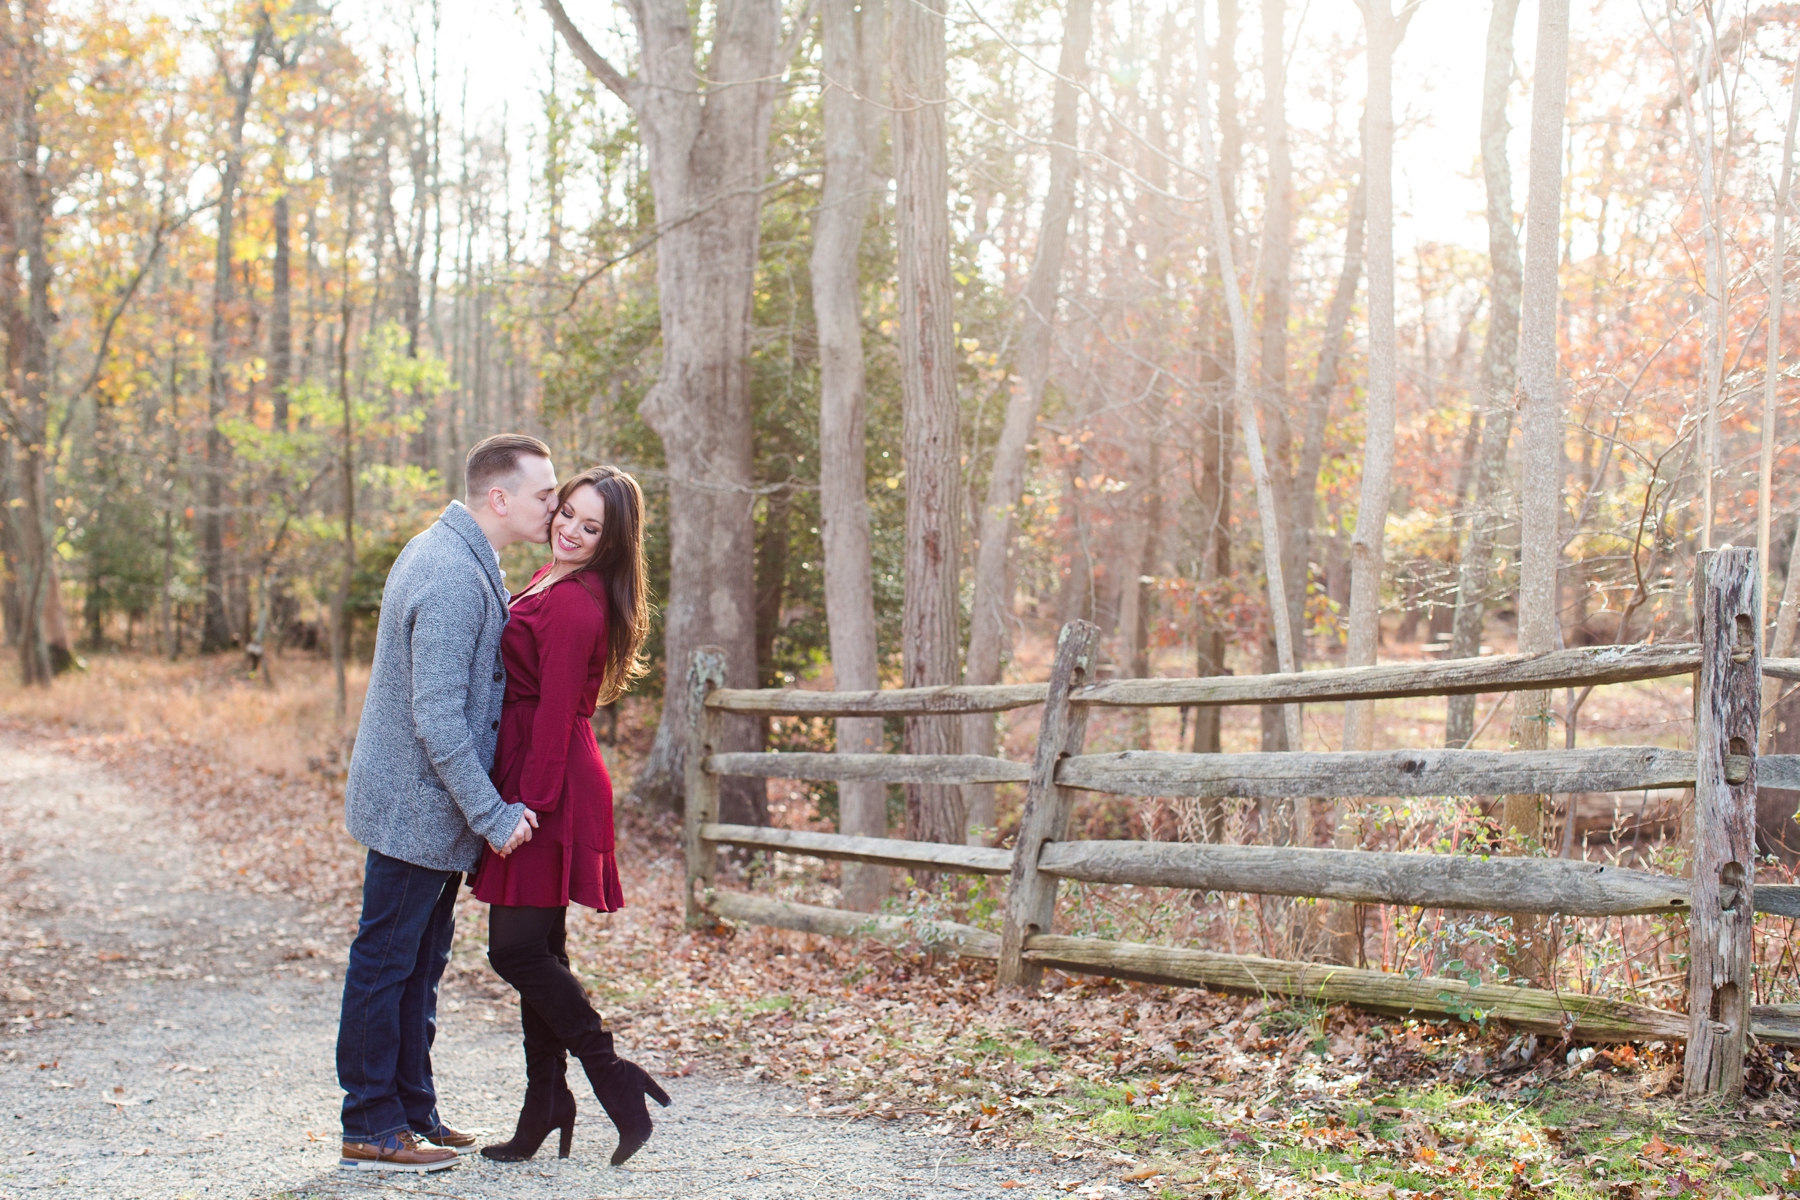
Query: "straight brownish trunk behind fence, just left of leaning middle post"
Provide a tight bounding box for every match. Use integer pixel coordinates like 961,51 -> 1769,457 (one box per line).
889,0 -> 967,842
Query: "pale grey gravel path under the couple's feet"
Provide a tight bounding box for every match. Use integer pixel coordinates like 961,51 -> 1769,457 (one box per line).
0,736 -> 1072,1200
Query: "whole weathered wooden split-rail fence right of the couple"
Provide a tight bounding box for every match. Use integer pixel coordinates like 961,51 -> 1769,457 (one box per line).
686,547 -> 1800,1097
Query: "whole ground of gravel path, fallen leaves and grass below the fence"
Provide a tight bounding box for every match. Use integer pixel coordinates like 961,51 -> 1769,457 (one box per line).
0,657 -> 1800,1200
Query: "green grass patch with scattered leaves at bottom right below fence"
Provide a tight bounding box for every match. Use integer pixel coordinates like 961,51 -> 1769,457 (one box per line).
1031,1076 -> 1800,1200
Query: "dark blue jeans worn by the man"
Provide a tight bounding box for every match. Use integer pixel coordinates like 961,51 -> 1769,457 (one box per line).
338,849 -> 463,1142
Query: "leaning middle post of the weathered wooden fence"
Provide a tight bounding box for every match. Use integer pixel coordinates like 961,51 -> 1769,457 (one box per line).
999,621 -> 1100,988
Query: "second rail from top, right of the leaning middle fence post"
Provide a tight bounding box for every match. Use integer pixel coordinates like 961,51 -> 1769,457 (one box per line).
1057,747 -> 1750,801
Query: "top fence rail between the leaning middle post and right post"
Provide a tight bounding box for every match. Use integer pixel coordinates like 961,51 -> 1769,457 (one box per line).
1069,644 -> 1706,707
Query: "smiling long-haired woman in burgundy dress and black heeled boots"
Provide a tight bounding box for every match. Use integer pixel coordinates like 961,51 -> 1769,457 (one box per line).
473,466 -> 670,1166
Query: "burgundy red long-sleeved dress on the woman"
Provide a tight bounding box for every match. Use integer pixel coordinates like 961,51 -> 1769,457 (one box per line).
473,567 -> 625,912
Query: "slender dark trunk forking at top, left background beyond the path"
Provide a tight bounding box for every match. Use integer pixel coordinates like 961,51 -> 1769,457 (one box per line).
200,16 -> 268,653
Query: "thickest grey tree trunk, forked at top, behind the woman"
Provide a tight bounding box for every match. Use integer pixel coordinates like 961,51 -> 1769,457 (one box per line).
542,0 -> 785,824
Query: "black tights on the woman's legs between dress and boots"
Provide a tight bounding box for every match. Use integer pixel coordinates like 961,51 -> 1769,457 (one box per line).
488,905 -> 601,1058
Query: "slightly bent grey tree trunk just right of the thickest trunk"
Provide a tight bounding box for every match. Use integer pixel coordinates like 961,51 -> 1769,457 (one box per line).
812,0 -> 889,912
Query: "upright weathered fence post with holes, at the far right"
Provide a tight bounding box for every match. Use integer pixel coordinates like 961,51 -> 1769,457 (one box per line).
1681,547 -> 1762,1099
